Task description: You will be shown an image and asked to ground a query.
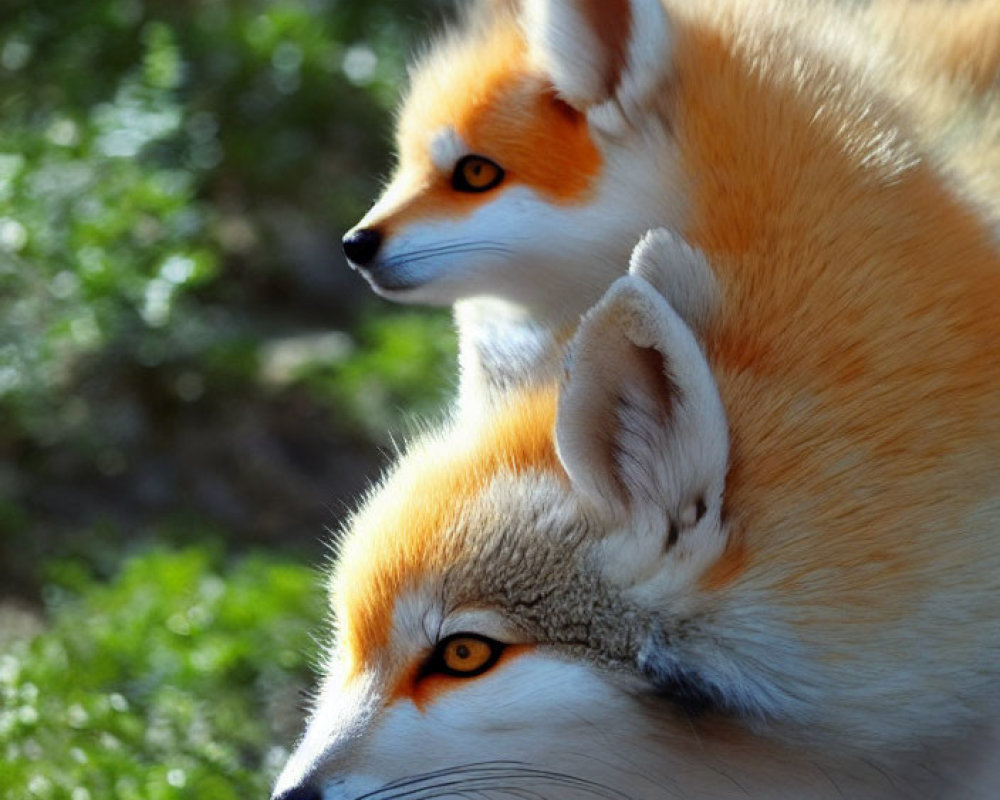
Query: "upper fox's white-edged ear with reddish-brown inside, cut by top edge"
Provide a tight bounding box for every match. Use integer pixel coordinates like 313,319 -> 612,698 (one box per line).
523,0 -> 671,116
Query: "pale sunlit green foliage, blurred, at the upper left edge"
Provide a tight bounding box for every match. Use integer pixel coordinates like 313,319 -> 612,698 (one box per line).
0,4 -> 209,441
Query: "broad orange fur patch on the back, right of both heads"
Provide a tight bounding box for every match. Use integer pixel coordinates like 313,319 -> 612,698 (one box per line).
675,7 -> 1000,613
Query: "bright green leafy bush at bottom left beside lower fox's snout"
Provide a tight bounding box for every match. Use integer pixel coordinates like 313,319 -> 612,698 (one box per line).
0,548 -> 322,800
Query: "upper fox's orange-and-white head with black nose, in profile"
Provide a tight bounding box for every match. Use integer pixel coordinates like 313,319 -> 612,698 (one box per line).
344,0 -> 682,321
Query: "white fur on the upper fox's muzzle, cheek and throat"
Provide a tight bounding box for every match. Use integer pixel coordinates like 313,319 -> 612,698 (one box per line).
359,130 -> 683,325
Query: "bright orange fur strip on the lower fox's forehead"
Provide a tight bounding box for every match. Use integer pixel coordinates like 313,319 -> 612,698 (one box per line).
332,387 -> 566,668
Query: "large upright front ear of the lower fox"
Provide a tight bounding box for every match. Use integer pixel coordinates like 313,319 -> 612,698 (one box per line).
556,275 -> 729,524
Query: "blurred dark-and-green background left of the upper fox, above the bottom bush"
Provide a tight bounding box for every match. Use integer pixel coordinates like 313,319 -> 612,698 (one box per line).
0,0 -> 454,576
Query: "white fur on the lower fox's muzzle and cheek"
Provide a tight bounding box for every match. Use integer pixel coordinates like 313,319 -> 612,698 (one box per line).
278,655 -> 648,800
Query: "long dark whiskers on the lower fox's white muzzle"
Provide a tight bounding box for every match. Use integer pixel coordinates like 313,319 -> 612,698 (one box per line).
354,761 -> 635,800
